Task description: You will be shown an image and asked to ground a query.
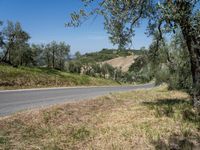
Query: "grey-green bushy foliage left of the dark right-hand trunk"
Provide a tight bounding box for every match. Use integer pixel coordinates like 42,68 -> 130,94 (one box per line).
149,34 -> 192,91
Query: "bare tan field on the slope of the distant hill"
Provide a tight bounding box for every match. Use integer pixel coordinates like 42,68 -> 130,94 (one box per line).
103,55 -> 138,72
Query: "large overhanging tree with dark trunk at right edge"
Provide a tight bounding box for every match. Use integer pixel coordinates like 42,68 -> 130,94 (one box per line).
67,0 -> 200,107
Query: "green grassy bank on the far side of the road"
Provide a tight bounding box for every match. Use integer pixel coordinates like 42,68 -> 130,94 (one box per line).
0,65 -> 119,89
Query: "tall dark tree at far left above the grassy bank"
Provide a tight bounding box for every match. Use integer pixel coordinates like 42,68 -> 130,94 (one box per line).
1,21 -> 30,66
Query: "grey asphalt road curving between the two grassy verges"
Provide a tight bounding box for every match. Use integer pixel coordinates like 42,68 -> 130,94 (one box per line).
0,83 -> 154,116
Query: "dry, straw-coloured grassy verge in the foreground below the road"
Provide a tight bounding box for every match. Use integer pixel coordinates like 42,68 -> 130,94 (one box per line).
0,86 -> 200,150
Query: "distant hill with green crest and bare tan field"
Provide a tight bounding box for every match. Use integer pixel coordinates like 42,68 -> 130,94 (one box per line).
72,49 -> 145,72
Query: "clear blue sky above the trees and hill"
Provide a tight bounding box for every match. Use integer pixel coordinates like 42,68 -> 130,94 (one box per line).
0,0 -> 151,53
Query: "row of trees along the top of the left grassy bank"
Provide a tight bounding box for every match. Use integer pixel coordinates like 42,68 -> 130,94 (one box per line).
0,21 -> 70,70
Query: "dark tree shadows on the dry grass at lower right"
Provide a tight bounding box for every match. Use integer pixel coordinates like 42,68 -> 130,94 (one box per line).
143,99 -> 200,150
